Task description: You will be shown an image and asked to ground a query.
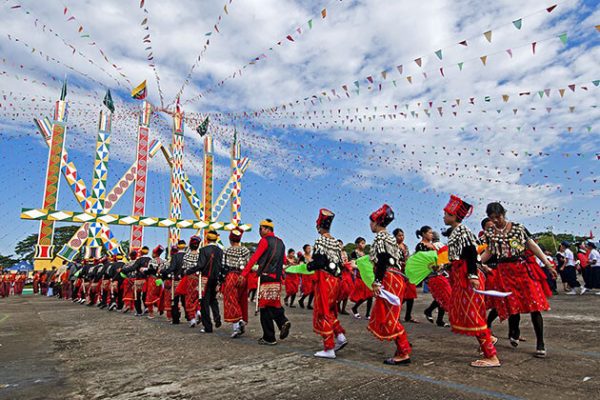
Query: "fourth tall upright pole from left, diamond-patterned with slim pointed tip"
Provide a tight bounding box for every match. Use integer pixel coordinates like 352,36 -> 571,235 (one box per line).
168,98 -> 184,251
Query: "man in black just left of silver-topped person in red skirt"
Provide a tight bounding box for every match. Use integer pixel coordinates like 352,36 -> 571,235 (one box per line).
162,240 -> 186,325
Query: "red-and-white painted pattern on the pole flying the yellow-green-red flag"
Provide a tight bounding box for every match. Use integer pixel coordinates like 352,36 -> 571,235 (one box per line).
130,125 -> 149,249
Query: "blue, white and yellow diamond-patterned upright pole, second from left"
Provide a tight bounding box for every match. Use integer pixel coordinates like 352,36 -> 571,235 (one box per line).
85,90 -> 114,258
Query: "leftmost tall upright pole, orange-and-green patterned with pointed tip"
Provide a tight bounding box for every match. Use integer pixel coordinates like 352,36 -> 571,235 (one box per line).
35,79 -> 68,269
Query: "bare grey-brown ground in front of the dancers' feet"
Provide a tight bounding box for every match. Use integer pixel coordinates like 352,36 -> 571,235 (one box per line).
0,295 -> 600,400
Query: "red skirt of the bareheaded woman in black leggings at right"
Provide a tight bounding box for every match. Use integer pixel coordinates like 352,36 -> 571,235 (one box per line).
496,258 -> 551,320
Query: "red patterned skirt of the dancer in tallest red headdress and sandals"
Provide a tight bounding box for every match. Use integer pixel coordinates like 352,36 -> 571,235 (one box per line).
449,260 -> 488,336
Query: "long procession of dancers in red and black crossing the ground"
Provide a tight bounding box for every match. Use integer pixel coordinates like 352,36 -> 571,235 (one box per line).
15,195 -> 600,368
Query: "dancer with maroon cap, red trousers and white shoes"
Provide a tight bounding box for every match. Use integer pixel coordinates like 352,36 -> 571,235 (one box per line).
307,208 -> 348,358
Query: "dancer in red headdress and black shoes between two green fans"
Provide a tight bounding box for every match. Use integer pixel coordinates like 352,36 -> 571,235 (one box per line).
367,204 -> 411,365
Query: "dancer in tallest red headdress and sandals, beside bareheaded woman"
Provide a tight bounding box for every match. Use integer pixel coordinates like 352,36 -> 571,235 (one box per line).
444,195 -> 500,368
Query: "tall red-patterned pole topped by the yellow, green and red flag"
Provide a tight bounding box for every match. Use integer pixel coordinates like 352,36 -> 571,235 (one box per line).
129,81 -> 152,250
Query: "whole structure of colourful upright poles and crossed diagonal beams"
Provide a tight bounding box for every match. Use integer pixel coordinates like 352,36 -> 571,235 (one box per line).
21,84 -> 252,269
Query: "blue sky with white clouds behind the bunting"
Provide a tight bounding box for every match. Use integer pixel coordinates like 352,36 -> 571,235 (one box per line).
0,0 -> 600,254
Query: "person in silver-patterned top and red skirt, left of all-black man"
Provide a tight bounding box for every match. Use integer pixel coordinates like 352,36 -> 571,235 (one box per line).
173,236 -> 202,328
